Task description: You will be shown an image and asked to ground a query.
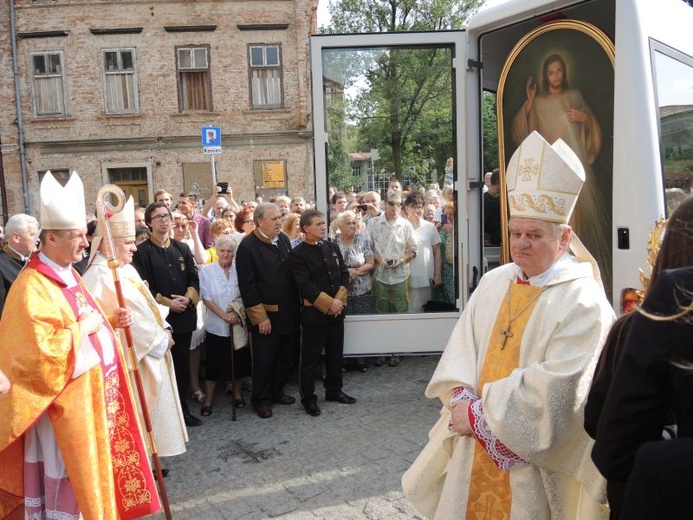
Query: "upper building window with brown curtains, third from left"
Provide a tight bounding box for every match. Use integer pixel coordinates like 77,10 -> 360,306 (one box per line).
176,46 -> 212,112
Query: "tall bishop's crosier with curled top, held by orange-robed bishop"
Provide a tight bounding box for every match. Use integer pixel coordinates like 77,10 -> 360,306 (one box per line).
96,184 -> 173,520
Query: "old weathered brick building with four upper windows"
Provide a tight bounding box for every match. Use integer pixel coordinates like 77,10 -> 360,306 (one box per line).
0,0 -> 318,221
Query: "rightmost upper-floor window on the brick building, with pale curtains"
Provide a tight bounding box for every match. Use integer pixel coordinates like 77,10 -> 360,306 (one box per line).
248,45 -> 282,108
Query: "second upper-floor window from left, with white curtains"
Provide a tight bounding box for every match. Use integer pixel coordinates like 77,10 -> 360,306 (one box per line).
103,49 -> 138,114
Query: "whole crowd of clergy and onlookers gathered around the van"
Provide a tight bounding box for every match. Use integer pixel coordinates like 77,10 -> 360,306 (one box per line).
0,129 -> 693,520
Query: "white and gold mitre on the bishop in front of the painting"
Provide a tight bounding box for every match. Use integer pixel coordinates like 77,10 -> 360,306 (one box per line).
505,131 -> 585,224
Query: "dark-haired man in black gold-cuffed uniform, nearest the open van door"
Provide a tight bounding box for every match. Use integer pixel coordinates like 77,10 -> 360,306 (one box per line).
289,209 -> 356,417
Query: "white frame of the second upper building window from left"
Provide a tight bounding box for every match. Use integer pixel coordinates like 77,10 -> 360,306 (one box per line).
101,47 -> 140,114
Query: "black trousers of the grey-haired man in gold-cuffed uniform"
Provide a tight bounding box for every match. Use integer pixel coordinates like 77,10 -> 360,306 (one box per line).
250,328 -> 298,409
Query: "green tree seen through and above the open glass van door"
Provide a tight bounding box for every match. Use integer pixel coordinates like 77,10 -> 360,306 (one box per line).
321,0 -> 483,186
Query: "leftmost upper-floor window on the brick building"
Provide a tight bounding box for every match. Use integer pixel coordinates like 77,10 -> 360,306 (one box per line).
31,52 -> 65,117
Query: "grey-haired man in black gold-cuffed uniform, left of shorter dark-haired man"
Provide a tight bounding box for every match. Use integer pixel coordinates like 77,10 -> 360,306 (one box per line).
236,202 -> 299,419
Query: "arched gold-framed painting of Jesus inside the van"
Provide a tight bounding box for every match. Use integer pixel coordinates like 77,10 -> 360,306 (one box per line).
496,20 -> 615,289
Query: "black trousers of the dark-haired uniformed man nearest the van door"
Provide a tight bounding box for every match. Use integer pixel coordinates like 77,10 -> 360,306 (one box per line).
300,320 -> 344,405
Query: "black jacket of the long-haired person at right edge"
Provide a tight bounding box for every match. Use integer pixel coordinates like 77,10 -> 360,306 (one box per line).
592,267 -> 693,516
